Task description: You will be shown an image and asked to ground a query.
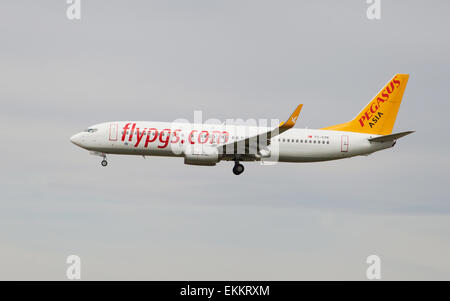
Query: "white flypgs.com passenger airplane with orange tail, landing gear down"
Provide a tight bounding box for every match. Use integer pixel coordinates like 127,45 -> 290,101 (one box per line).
70,74 -> 414,175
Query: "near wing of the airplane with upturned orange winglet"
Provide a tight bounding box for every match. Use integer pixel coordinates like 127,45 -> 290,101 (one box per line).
217,104 -> 303,160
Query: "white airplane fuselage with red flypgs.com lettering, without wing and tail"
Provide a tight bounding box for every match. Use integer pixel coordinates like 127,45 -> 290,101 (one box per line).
71,121 -> 393,162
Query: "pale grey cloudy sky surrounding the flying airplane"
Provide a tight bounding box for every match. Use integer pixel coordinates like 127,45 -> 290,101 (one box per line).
0,0 -> 450,280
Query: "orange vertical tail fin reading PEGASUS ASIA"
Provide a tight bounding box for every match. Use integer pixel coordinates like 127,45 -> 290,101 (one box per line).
322,74 -> 409,135
